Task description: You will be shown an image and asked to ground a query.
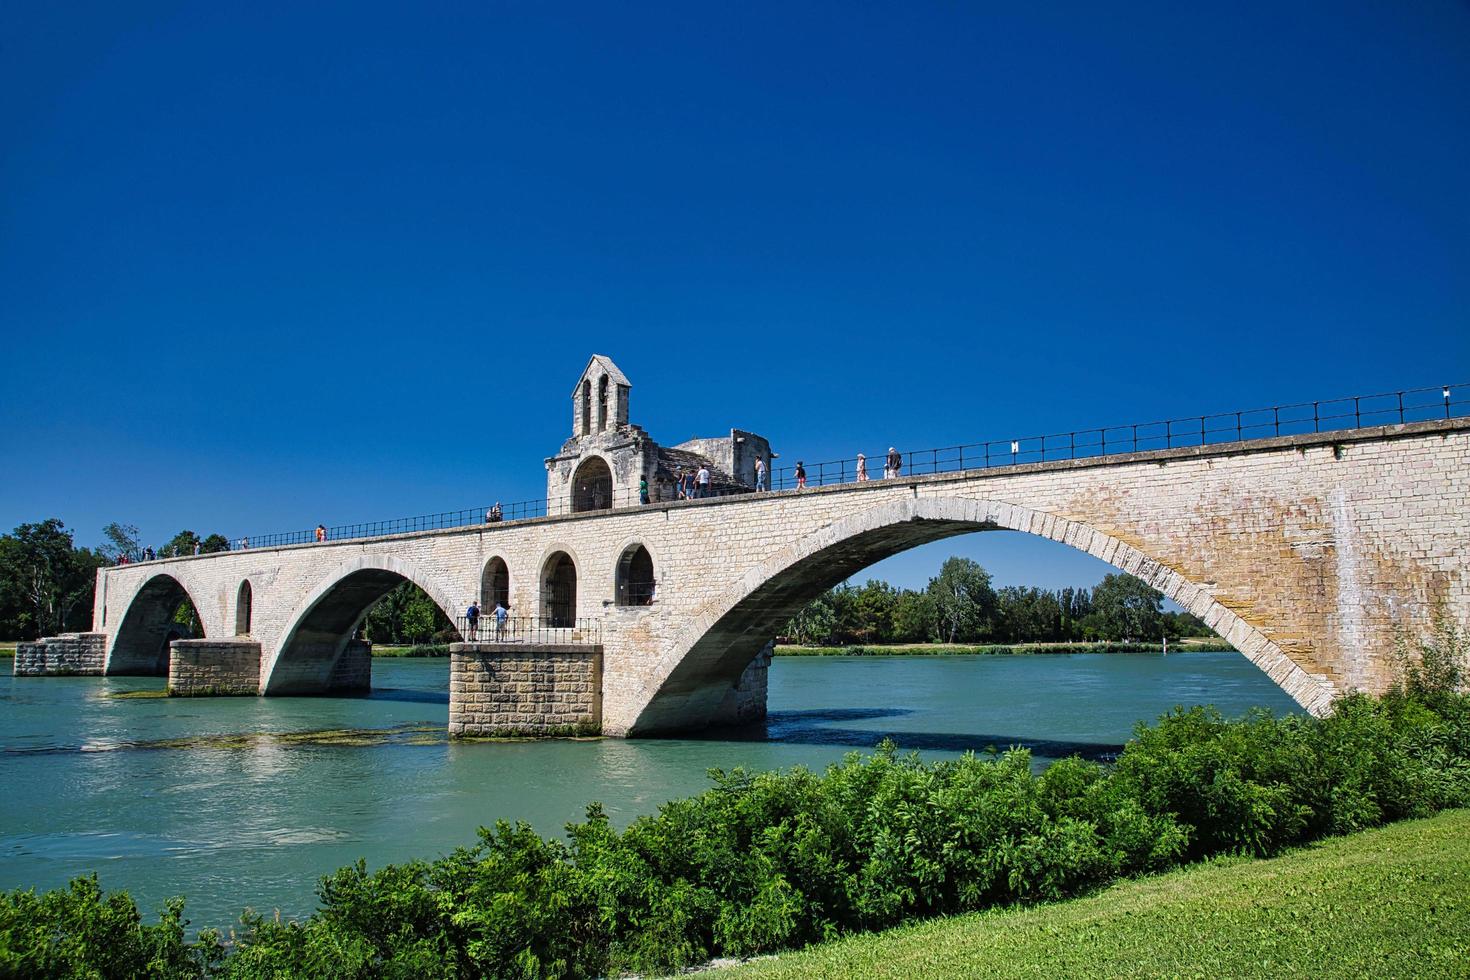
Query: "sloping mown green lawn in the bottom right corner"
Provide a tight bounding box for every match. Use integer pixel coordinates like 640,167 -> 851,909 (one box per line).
716,810 -> 1470,980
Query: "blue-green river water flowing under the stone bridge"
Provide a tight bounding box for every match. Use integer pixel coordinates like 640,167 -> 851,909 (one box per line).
0,654 -> 1297,927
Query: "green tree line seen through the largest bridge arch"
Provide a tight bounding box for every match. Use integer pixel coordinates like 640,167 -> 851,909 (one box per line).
782,557 -> 1211,645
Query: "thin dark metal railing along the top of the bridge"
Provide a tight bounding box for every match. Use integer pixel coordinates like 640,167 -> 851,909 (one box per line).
177,385 -> 1470,550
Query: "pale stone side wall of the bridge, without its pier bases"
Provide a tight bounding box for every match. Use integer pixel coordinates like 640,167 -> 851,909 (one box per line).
94,419 -> 1470,735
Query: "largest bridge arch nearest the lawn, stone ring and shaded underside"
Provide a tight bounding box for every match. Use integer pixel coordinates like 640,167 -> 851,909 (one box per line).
626,497 -> 1338,735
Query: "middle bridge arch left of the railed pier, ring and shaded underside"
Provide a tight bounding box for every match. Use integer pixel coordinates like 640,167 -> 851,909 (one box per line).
263,555 -> 456,695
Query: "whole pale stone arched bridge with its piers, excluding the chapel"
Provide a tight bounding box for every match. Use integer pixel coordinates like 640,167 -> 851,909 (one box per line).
16,419 -> 1470,736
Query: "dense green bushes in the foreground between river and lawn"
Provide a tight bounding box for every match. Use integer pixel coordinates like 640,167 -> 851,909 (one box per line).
0,626 -> 1470,977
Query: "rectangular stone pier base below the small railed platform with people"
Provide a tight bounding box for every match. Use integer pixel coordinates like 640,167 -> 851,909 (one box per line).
450,644 -> 603,738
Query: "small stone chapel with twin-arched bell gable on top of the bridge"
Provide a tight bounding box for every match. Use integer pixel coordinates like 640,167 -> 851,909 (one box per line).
547,354 -> 773,514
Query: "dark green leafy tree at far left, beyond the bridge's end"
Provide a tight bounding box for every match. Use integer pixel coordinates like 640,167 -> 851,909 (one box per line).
0,517 -> 104,639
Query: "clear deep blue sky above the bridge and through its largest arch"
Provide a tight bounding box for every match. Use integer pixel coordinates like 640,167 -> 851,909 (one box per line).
0,0 -> 1470,586
